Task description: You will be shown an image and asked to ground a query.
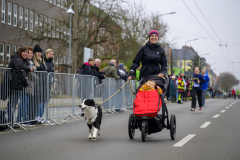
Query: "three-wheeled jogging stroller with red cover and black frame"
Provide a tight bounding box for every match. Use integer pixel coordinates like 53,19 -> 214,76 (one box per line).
128,76 -> 176,142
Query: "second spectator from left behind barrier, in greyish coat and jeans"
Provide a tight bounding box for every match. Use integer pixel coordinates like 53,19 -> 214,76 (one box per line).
17,47 -> 38,126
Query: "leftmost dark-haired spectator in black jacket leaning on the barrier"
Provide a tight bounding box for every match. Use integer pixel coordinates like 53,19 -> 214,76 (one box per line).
7,47 -> 34,124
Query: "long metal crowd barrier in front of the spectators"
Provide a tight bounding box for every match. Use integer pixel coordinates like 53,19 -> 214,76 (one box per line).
0,68 -> 137,132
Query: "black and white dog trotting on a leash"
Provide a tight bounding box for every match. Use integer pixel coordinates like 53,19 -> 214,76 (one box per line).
79,99 -> 102,140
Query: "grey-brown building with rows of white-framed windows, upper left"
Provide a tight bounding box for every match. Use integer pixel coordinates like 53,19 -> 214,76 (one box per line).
0,0 -> 69,71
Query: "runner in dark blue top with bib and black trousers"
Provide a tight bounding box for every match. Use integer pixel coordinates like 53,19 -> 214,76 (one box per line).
190,67 -> 205,112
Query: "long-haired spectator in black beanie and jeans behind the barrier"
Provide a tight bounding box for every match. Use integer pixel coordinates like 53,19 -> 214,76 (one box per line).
33,45 -> 47,122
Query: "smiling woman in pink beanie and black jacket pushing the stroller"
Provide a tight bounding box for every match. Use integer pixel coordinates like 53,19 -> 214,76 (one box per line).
128,30 -> 167,79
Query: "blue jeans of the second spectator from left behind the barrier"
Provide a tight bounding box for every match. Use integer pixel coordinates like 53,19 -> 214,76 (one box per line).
17,94 -> 29,122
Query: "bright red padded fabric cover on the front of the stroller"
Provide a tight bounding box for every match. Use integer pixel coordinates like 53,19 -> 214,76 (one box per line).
133,89 -> 162,117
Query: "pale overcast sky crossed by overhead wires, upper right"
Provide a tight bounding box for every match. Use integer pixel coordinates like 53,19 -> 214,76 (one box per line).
129,0 -> 240,79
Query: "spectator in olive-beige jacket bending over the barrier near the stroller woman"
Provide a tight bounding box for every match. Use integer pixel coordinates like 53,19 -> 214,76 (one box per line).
103,59 -> 120,79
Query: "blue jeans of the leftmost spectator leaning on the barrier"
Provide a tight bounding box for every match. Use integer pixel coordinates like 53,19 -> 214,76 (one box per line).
7,90 -> 21,124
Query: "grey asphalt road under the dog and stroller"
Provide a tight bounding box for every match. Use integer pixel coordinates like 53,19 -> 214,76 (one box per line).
0,99 -> 240,160
